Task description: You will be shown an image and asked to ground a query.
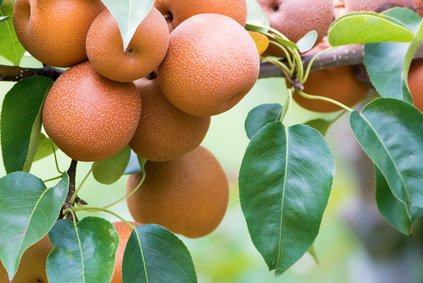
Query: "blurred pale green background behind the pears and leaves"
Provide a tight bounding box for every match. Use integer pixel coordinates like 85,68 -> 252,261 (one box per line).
0,52 -> 423,283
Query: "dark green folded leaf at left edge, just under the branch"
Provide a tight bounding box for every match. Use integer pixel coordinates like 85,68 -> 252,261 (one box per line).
1,77 -> 53,173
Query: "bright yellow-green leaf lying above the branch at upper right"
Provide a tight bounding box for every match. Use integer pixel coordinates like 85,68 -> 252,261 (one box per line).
328,12 -> 414,46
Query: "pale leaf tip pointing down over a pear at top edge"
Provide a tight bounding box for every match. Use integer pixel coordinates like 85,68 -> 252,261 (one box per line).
101,0 -> 154,50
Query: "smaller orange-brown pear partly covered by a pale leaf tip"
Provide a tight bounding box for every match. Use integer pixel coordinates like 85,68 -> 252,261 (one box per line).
87,8 -> 169,82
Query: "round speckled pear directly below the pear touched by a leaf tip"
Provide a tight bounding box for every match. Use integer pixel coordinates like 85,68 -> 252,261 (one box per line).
42,63 -> 142,161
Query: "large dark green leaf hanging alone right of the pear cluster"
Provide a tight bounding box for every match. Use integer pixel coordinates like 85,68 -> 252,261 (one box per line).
239,122 -> 335,274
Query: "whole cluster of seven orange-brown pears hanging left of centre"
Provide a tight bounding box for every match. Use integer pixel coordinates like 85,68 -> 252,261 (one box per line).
14,0 -> 260,246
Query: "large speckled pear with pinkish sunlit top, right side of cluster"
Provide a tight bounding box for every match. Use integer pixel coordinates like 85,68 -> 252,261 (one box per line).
158,14 -> 260,117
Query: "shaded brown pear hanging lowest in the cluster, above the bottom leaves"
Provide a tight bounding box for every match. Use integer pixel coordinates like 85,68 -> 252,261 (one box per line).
126,147 -> 229,238
